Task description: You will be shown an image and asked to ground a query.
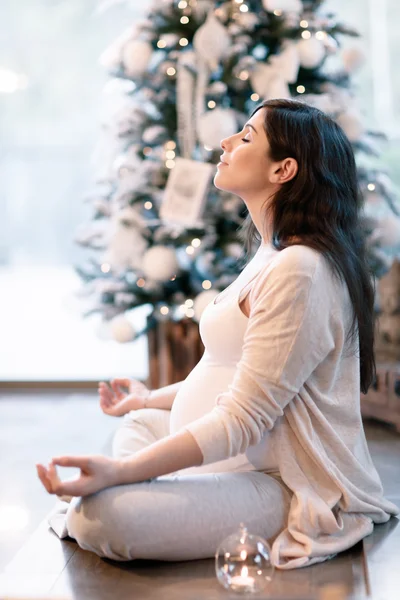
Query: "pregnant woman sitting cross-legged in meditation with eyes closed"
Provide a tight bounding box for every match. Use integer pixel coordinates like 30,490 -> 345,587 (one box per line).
37,100 -> 398,569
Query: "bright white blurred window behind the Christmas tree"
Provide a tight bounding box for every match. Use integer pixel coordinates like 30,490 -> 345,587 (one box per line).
0,0 -> 400,381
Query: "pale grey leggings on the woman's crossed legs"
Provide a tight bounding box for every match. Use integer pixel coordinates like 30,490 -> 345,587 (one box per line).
66,408 -> 291,561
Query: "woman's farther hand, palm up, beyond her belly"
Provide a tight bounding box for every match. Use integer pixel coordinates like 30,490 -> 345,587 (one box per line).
99,378 -> 150,417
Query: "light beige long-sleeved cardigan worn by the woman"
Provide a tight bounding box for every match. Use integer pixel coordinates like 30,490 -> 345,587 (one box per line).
183,245 -> 399,569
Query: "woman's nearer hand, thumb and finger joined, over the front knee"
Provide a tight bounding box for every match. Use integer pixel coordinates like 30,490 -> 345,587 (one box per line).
36,455 -> 119,496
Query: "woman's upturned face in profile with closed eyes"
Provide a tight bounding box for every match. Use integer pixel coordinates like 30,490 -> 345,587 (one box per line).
214,108 -> 276,200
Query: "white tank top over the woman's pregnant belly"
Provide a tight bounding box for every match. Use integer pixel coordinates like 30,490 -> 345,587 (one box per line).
170,243 -> 278,474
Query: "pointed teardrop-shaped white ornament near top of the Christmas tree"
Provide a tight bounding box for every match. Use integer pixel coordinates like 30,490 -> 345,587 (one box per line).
193,10 -> 231,71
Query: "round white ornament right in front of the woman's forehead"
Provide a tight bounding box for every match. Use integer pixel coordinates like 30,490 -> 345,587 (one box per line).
198,108 -> 237,149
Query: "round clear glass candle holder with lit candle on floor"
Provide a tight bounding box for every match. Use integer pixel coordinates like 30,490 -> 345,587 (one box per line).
215,523 -> 274,594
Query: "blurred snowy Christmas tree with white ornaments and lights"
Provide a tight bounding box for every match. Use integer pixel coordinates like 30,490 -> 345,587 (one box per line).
77,0 -> 400,341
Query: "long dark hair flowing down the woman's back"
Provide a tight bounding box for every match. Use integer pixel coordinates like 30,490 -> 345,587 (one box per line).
239,99 -> 376,394
